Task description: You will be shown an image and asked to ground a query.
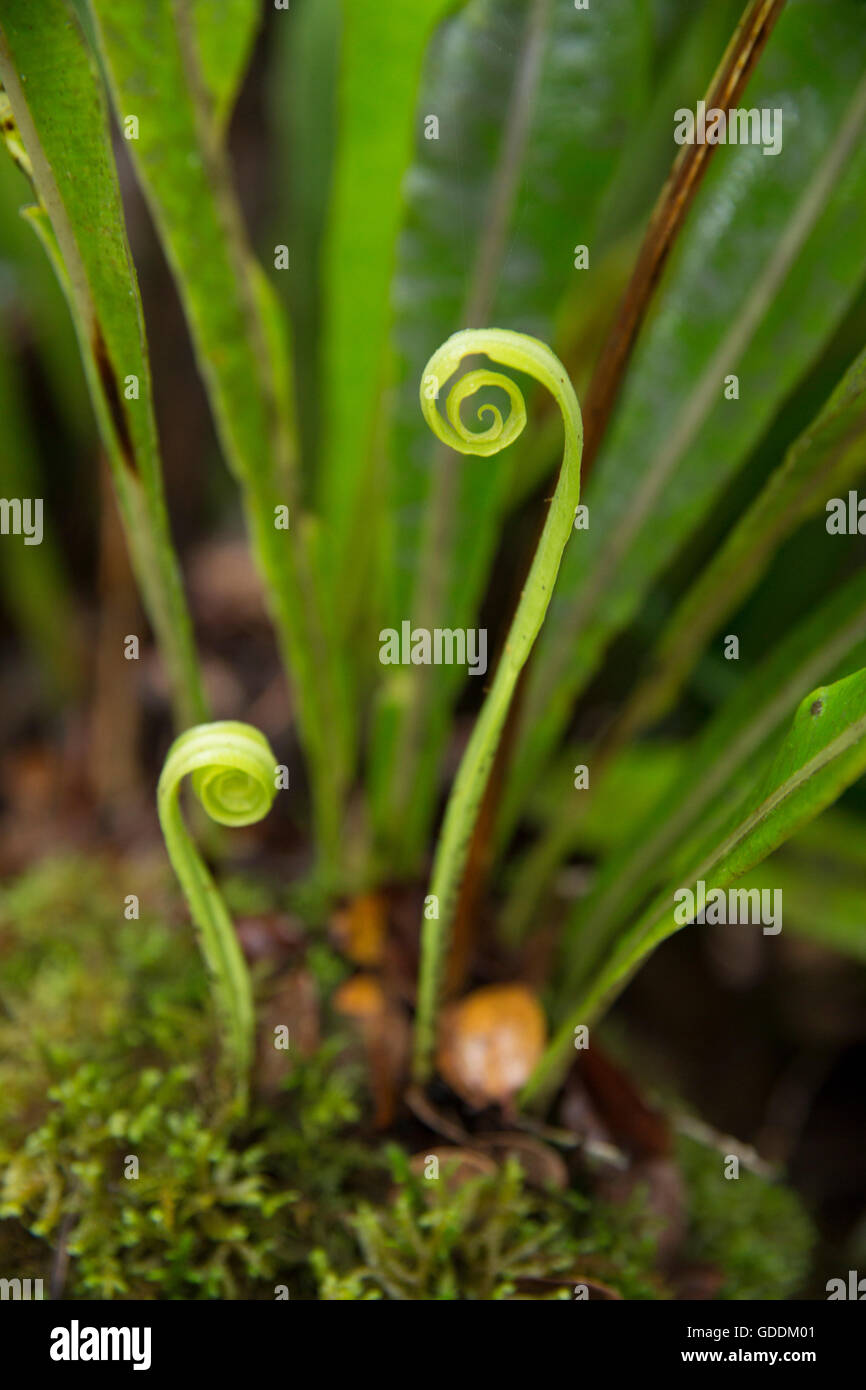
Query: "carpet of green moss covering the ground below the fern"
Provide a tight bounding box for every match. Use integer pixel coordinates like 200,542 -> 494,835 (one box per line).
0,859 -> 809,1301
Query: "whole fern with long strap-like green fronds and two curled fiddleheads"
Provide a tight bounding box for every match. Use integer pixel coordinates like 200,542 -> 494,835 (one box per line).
0,0 -> 866,1217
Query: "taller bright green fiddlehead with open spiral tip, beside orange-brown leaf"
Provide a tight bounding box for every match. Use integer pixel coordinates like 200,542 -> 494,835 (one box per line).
414,328 -> 584,1081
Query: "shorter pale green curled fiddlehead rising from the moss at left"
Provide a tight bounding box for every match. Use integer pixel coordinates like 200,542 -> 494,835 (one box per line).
157,720 -> 277,1109
